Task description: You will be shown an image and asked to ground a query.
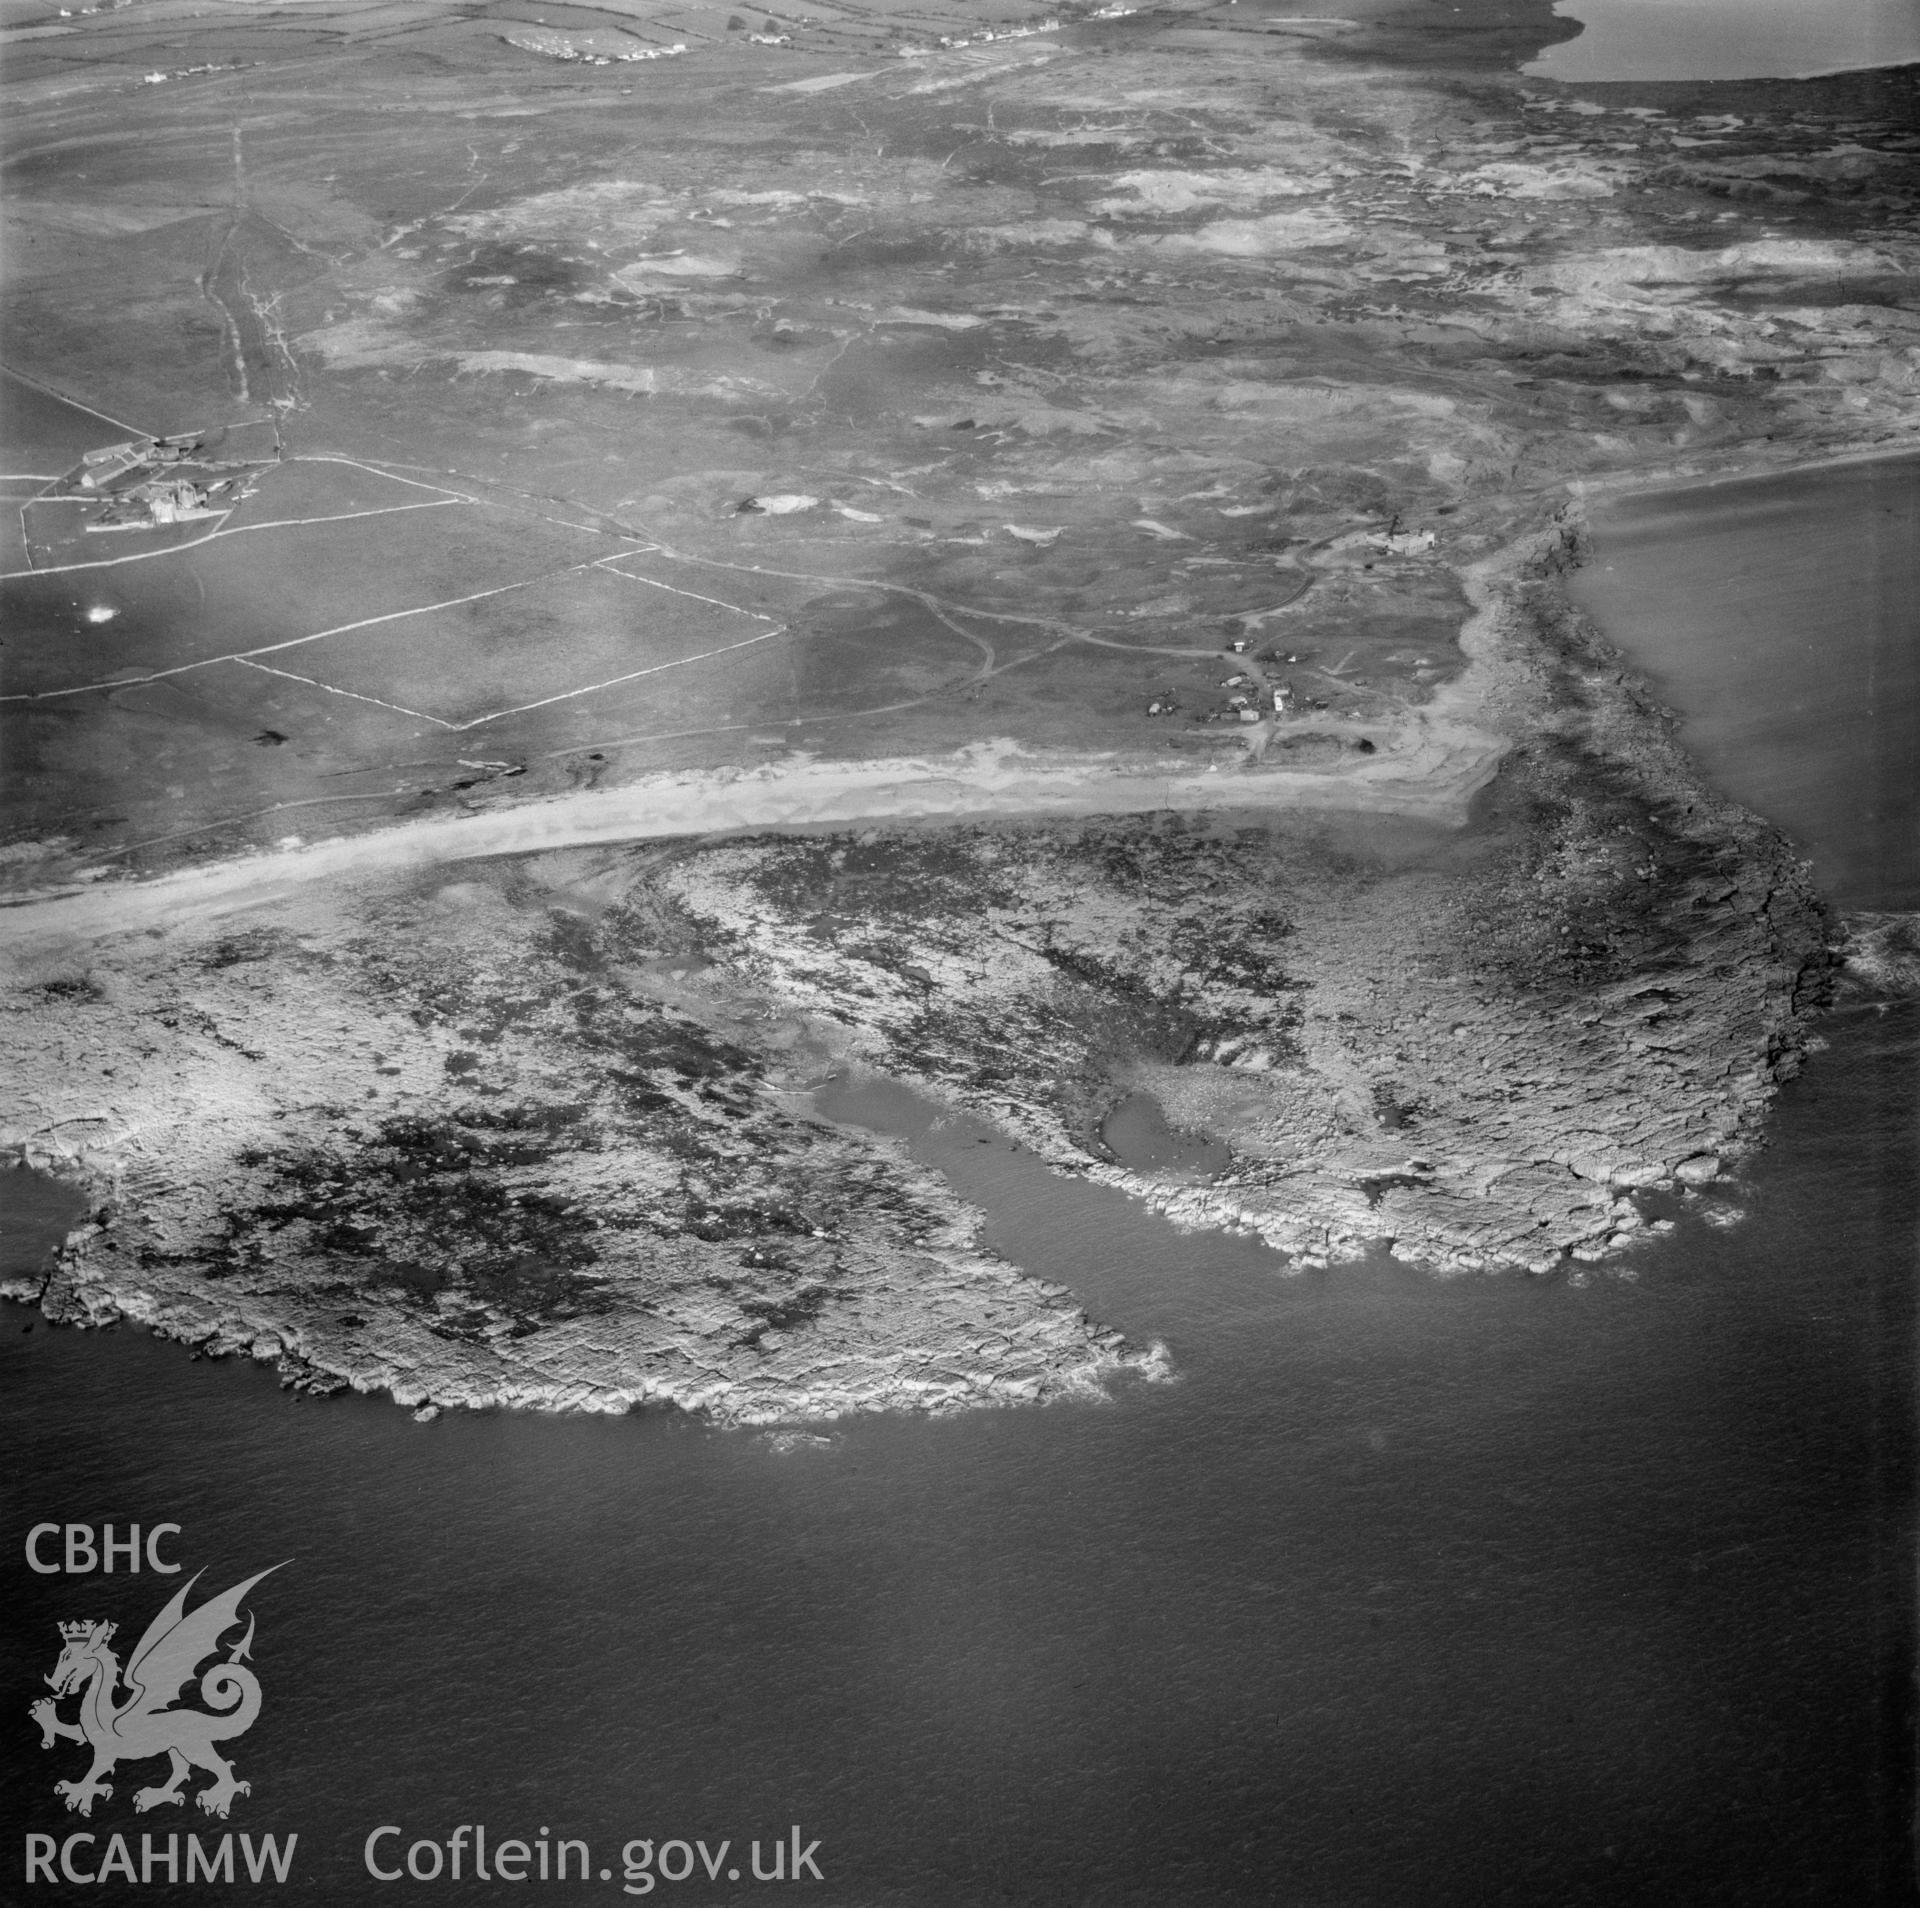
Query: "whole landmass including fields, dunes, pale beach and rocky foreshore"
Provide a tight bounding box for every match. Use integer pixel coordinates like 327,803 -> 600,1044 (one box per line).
0,0 -> 1920,1417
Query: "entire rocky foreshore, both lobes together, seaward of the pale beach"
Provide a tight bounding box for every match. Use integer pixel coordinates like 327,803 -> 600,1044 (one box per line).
4,509 -> 1837,1422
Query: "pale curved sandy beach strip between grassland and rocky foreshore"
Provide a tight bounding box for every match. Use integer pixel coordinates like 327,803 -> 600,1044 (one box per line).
0,720 -> 1505,958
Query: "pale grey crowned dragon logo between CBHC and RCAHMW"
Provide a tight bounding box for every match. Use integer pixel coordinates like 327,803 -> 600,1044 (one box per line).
29,1564 -> 282,1818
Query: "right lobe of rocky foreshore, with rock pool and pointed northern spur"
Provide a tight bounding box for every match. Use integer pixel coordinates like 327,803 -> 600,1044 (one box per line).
662,516 -> 1834,1271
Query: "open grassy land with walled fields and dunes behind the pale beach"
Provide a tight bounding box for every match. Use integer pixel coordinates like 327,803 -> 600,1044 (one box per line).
0,0 -> 1920,887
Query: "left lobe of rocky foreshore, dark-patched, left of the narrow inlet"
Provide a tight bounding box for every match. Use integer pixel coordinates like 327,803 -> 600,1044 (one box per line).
6,871 -> 1164,1422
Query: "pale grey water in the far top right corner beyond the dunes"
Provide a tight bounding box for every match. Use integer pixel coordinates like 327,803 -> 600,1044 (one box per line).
1524,0 -> 1920,84
